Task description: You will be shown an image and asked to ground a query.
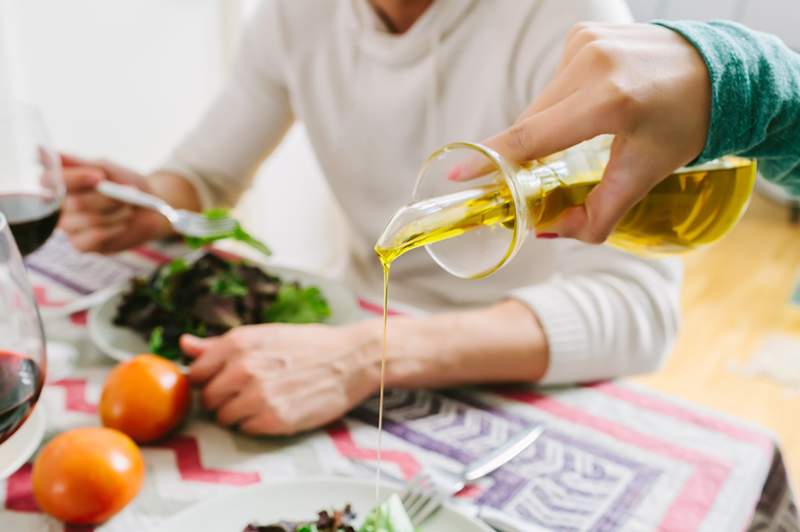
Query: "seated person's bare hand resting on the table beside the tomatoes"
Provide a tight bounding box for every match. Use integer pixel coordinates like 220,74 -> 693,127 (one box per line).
181,324 -> 379,435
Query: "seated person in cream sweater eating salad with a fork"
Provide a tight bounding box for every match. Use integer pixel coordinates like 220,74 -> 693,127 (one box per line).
61,0 -> 681,434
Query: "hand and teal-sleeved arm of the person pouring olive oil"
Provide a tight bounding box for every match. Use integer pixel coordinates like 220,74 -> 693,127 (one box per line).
476,21 -> 800,243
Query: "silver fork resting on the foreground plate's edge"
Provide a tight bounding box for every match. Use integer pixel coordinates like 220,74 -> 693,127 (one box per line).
400,426 -> 544,527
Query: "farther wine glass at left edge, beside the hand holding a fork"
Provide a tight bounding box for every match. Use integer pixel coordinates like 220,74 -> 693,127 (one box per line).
0,101 -> 64,256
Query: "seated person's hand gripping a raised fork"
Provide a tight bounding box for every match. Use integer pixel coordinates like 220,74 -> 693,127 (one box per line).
59,154 -> 170,253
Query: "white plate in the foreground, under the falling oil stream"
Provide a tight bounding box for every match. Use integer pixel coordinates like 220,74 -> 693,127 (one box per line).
152,478 -> 491,532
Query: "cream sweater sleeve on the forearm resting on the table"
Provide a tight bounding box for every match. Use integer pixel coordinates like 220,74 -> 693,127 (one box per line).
512,240 -> 681,384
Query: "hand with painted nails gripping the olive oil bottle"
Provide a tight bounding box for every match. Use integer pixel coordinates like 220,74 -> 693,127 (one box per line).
467,23 -> 711,243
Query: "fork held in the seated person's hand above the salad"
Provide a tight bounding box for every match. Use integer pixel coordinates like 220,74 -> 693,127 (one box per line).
97,181 -> 236,238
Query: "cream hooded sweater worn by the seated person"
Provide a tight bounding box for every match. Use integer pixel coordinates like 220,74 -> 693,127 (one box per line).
165,0 -> 680,383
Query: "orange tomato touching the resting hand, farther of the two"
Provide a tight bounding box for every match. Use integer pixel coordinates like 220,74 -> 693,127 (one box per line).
100,355 -> 191,443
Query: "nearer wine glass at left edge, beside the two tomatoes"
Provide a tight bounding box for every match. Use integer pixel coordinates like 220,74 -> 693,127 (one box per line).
0,213 -> 47,478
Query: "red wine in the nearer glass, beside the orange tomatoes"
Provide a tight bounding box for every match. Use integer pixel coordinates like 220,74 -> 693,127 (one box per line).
0,351 -> 44,443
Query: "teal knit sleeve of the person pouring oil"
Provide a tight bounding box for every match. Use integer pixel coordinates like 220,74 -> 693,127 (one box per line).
654,20 -> 800,196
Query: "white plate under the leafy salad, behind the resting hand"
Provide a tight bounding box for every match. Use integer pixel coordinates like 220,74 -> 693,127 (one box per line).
88,266 -> 365,362
